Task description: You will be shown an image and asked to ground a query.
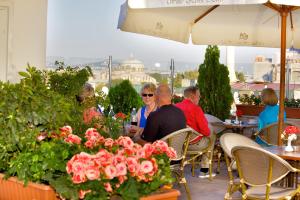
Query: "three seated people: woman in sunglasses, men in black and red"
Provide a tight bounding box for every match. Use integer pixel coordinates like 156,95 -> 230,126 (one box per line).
129,84 -> 213,178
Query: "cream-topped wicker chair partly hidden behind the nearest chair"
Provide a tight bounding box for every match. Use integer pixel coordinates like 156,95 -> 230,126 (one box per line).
220,133 -> 260,199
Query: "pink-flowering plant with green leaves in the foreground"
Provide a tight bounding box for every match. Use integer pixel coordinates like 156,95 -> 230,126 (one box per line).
0,127 -> 178,200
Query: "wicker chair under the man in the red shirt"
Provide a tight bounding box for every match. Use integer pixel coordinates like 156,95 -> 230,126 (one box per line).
187,128 -> 216,180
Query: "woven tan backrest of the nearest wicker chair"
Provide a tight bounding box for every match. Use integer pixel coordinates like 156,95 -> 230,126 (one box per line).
231,146 -> 295,186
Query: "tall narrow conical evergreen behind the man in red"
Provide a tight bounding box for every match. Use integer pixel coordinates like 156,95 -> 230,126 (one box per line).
198,45 -> 233,120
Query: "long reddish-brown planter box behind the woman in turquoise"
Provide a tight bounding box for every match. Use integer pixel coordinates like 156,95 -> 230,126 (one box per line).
236,104 -> 300,119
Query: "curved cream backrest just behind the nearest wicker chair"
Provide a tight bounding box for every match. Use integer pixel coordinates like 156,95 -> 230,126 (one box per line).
220,133 -> 260,158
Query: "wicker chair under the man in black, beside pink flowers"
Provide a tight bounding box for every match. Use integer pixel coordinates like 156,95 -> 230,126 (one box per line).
161,128 -> 192,199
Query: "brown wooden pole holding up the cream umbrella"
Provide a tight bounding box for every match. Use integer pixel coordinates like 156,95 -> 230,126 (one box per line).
278,6 -> 288,146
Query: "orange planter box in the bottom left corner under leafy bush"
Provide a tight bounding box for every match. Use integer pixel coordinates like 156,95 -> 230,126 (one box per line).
0,174 -> 57,200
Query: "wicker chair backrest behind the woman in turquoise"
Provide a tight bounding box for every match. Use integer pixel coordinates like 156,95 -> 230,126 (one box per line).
257,122 -> 295,145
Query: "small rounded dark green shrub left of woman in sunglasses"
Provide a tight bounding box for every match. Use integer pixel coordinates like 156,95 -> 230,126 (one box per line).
108,80 -> 143,114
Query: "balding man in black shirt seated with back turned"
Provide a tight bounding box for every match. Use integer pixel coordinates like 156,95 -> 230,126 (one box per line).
137,84 -> 186,144
